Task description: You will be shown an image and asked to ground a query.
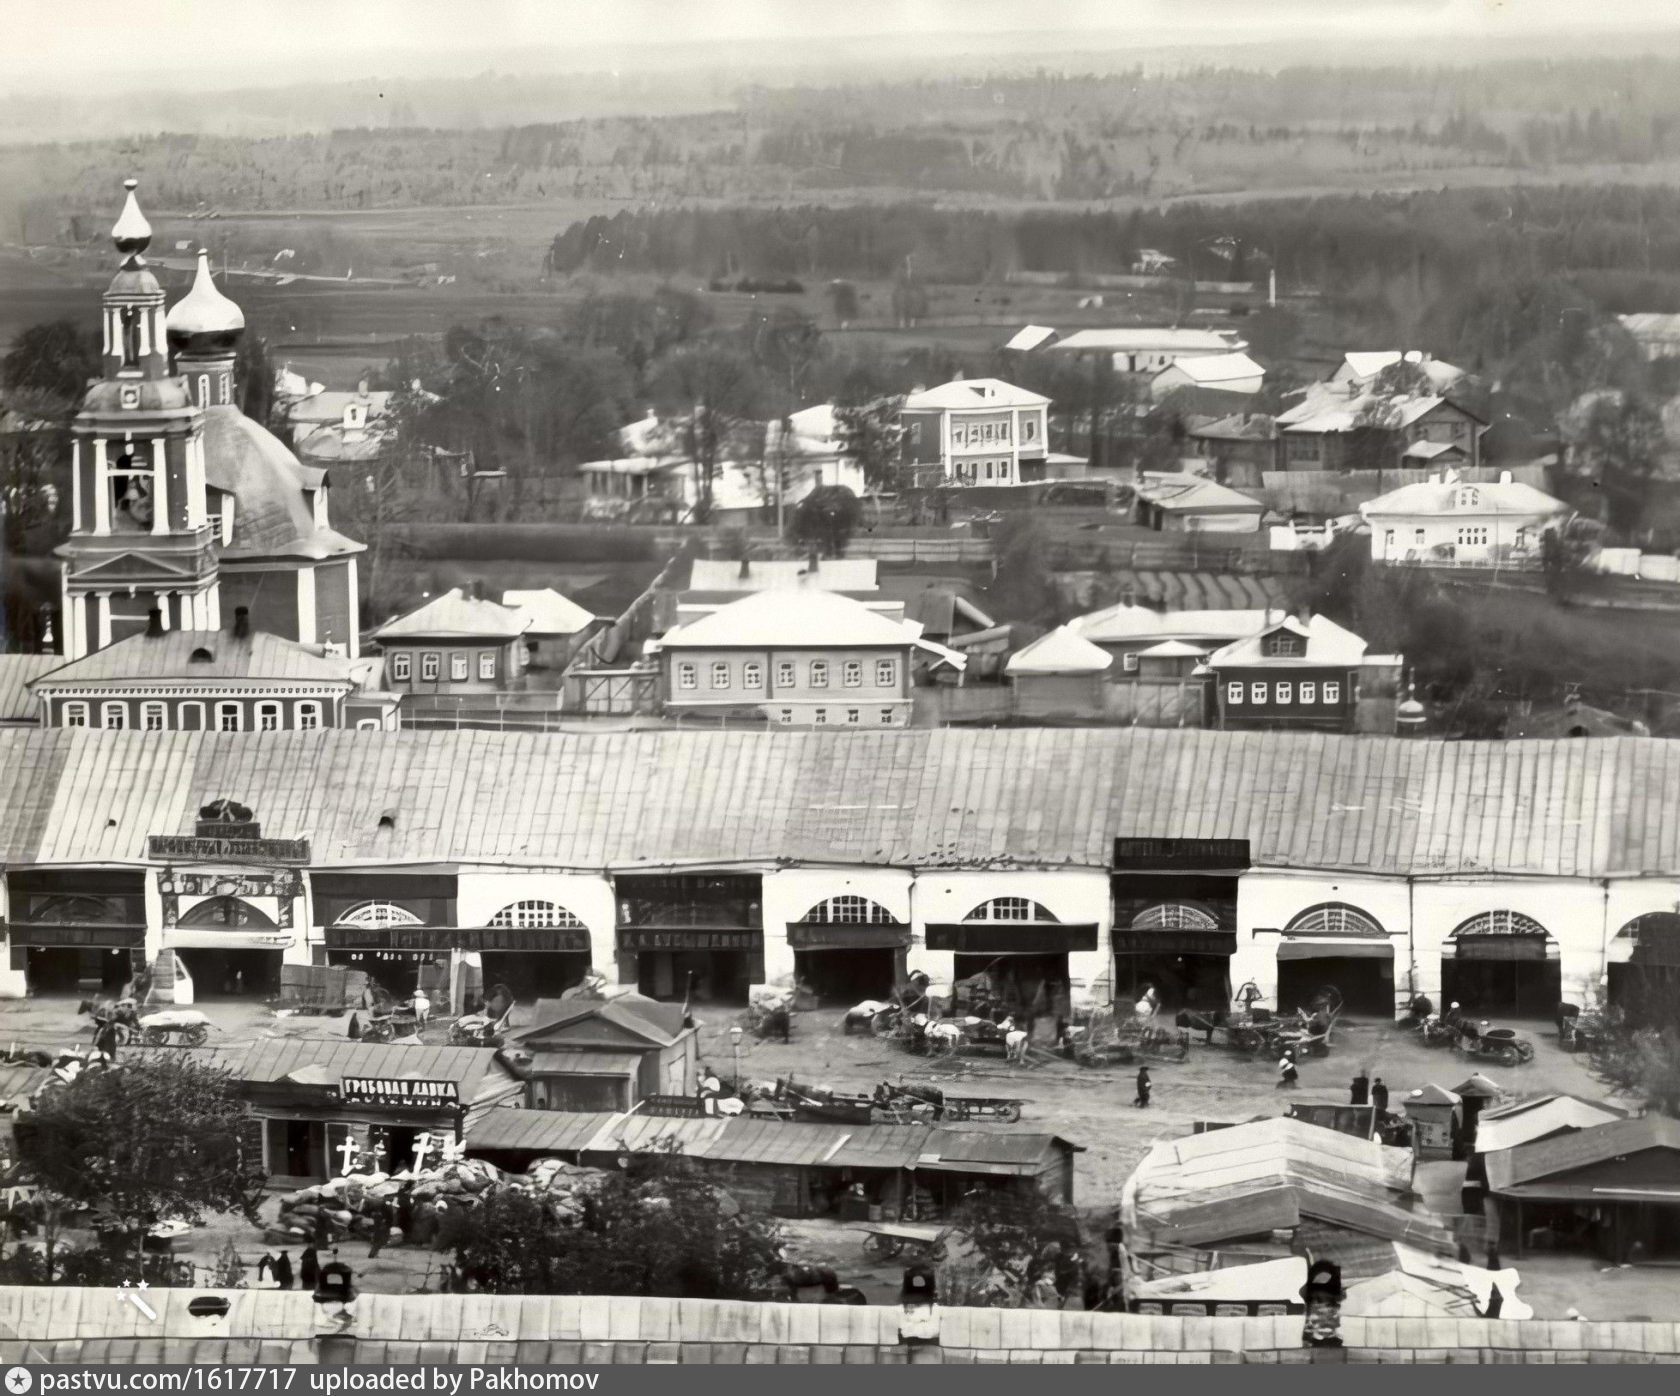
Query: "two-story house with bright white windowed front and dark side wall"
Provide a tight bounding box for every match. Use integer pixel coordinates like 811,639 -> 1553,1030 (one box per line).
899,378 -> 1050,485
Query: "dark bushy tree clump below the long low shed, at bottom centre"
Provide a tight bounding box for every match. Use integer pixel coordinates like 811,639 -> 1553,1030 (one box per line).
442,1156 -> 780,1299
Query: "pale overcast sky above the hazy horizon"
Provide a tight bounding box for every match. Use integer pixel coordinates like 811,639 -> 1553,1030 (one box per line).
13,0 -> 1680,89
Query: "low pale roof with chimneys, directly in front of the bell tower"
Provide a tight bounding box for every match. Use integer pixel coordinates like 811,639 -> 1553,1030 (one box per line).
32,630 -> 365,690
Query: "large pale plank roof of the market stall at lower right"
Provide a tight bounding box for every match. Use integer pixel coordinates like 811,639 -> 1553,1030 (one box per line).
1121,1119 -> 1452,1250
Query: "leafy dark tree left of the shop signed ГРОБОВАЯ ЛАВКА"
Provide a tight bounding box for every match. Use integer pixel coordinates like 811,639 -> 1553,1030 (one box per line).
18,1052 -> 267,1255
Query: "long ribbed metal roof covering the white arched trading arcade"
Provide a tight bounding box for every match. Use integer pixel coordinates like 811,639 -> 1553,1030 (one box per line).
0,727 -> 1680,879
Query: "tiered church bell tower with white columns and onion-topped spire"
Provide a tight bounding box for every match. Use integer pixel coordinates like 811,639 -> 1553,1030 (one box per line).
57,180 -> 220,659
